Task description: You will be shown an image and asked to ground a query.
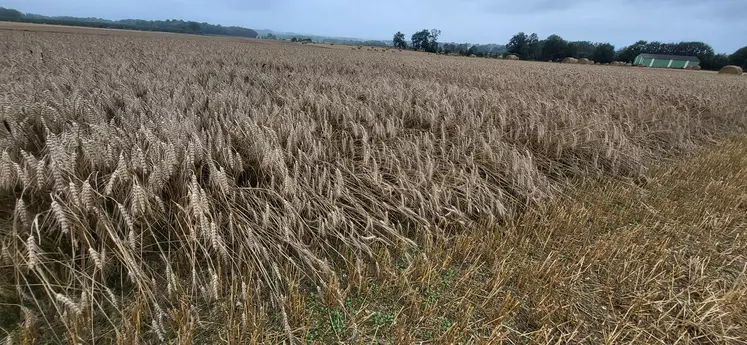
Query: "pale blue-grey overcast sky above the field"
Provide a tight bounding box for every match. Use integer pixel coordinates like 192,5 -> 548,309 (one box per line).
0,0 -> 747,53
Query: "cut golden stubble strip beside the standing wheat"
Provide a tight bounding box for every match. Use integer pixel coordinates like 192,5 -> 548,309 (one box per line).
288,137 -> 747,344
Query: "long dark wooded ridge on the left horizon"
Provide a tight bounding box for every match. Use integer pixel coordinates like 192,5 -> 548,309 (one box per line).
0,7 -> 258,38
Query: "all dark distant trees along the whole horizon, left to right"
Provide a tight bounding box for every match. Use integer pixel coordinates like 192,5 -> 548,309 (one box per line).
0,7 -> 747,70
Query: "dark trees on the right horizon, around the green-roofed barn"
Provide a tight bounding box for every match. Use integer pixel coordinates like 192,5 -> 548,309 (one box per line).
392,29 -> 747,70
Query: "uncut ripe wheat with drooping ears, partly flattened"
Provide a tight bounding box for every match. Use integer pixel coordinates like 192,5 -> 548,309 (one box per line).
0,31 -> 747,343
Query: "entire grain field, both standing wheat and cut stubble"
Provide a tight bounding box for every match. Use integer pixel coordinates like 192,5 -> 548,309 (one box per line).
0,25 -> 747,344
